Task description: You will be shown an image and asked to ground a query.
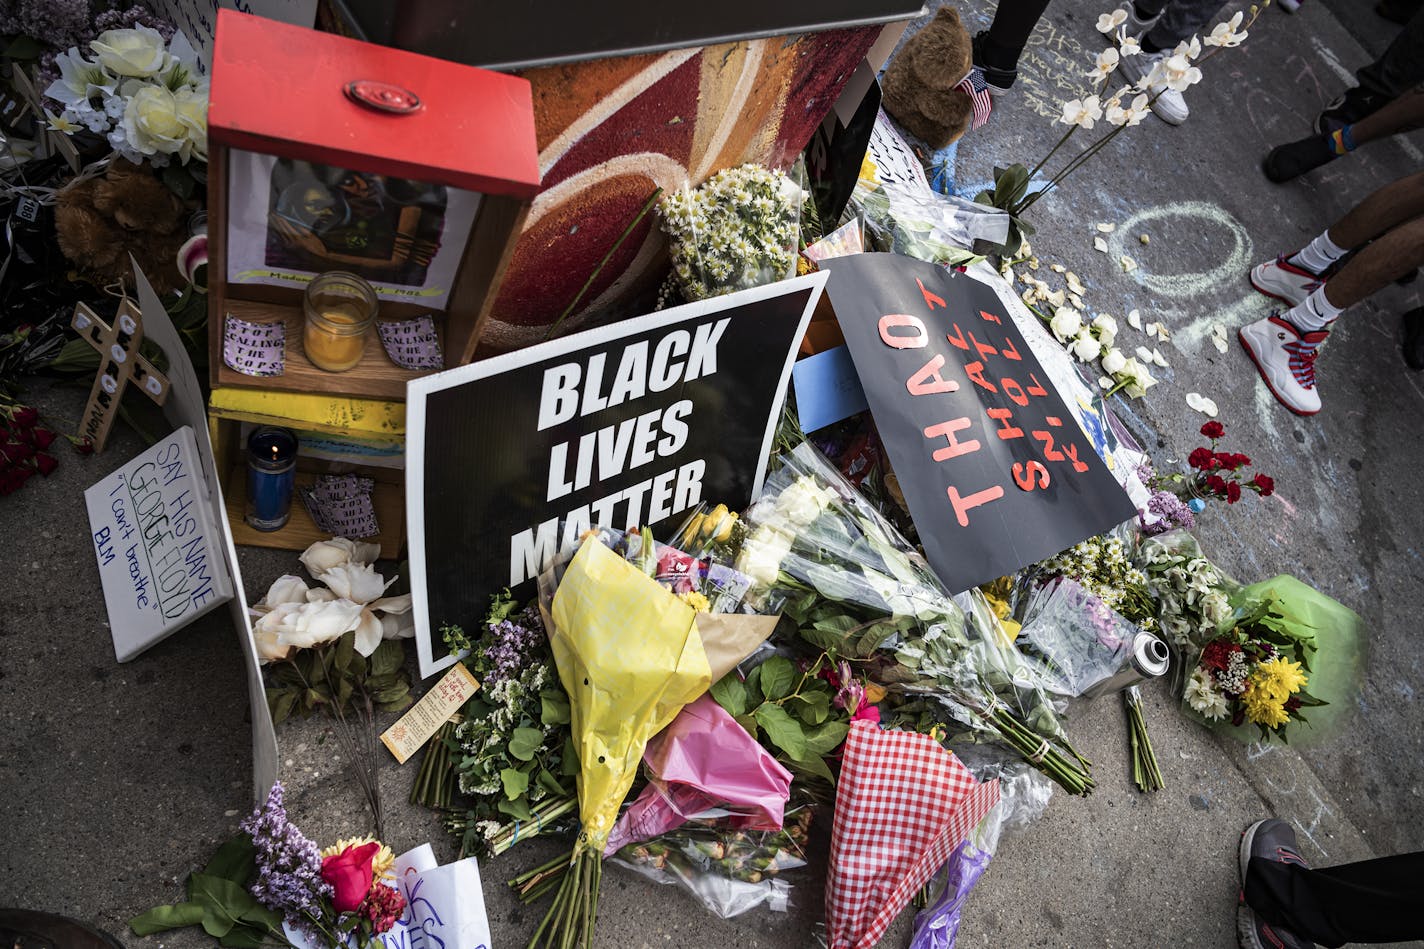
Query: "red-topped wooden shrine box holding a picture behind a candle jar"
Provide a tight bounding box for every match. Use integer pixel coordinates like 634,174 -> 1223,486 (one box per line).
208,10 -> 540,399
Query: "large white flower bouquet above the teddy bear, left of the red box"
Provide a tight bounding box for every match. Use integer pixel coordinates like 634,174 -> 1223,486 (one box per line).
44,23 -> 208,168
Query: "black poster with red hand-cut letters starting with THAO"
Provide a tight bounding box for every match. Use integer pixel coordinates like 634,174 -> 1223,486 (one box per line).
822,254 -> 1135,591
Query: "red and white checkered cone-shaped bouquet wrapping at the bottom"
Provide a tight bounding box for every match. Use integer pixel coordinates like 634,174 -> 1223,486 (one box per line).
826,722 -> 998,949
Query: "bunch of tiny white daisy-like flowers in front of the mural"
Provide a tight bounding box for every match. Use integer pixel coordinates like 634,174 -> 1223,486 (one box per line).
659,164 -> 805,302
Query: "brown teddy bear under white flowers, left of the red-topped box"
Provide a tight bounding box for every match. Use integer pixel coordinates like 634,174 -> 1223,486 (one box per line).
54,158 -> 195,294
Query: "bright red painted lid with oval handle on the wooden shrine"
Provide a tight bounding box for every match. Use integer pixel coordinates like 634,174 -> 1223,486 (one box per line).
208,9 -> 540,198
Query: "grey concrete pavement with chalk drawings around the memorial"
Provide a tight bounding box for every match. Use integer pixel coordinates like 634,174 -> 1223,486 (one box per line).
0,0 -> 1424,949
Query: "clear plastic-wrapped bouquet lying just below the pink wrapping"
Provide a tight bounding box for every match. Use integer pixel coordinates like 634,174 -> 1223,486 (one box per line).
611,807 -> 812,919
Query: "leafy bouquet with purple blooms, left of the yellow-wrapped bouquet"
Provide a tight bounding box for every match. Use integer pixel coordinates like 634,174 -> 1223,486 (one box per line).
432,590 -> 578,856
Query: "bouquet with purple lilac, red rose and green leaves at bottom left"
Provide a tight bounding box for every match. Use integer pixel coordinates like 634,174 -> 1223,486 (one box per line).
128,782 -> 406,949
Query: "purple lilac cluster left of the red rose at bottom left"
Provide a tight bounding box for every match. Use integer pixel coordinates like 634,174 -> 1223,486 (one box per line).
239,781 -> 332,930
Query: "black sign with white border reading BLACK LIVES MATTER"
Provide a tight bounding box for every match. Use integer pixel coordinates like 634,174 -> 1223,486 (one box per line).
406,274 -> 826,675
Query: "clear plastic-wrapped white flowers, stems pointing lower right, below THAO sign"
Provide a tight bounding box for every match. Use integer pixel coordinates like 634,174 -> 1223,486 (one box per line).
736,442 -> 1092,794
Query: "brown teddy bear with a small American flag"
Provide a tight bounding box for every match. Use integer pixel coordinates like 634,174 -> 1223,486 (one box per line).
881,7 -> 974,151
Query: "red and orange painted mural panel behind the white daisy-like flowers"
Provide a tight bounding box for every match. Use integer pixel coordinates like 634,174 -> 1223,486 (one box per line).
480,27 -> 880,355
